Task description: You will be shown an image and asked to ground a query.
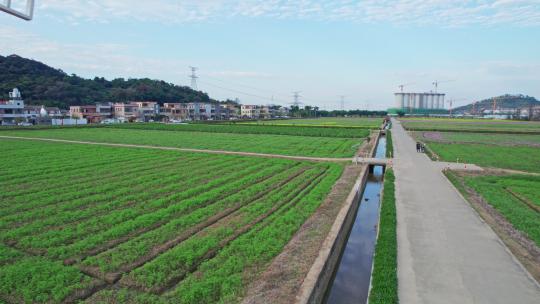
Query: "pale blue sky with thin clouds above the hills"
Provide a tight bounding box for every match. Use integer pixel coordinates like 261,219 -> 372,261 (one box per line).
0,0 -> 540,110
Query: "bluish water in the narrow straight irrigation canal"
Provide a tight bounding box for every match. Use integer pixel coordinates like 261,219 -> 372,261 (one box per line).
325,136 -> 386,304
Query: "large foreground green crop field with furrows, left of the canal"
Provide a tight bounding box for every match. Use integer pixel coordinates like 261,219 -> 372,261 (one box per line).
0,139 -> 343,303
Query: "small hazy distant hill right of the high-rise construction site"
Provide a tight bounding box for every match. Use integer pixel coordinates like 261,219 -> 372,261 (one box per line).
454,94 -> 540,113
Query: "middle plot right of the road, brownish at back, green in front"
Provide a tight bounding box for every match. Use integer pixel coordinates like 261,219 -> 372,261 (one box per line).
414,131 -> 540,172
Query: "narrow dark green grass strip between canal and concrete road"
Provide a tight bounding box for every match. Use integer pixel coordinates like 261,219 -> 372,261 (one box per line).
369,169 -> 399,304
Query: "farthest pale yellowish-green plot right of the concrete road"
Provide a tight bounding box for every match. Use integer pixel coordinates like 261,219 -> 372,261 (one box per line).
400,118 -> 540,134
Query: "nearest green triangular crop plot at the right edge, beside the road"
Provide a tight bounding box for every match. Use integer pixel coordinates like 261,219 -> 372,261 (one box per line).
450,174 -> 540,246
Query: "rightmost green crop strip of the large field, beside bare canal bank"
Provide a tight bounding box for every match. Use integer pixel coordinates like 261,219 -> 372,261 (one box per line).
165,165 -> 342,303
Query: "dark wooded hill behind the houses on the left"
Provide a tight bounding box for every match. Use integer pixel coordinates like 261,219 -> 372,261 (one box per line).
0,55 -> 215,109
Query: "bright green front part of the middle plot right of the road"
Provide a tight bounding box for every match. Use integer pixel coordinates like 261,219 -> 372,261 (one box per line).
428,142 -> 540,172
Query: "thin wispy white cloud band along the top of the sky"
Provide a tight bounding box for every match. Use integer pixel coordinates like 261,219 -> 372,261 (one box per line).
36,0 -> 540,27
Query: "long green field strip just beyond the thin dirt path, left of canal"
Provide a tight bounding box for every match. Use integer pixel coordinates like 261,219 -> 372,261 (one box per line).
0,128 -> 363,158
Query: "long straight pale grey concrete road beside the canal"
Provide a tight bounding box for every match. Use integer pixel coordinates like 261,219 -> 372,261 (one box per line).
392,120 -> 540,304
